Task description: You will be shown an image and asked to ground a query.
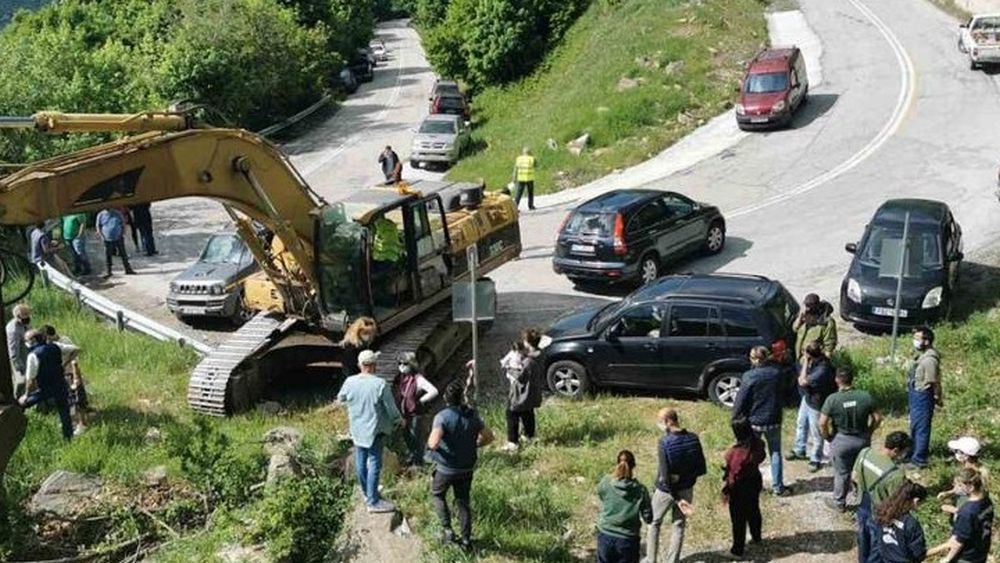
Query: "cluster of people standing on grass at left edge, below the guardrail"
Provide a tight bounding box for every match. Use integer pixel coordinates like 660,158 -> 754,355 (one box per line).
6,304 -> 90,440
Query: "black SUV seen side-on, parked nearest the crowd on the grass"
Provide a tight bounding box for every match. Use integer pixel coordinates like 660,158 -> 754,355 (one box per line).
544,274 -> 799,406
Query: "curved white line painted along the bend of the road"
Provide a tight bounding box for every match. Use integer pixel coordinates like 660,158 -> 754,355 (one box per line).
726,0 -> 916,219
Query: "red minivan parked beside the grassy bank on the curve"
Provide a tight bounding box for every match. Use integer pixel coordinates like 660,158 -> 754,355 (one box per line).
736,47 -> 809,130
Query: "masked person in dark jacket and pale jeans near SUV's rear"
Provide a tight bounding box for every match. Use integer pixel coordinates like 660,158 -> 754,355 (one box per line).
785,341 -> 837,473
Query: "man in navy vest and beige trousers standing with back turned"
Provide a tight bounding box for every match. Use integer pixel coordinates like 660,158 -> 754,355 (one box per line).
643,408 -> 706,563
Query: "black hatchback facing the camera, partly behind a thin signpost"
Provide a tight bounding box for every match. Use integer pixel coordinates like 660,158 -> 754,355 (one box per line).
840,199 -> 963,328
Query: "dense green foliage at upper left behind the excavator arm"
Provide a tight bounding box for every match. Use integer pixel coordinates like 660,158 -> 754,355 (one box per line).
0,0 -> 375,162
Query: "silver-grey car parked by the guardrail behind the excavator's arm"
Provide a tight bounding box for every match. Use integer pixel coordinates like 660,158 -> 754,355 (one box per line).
167,230 -> 260,324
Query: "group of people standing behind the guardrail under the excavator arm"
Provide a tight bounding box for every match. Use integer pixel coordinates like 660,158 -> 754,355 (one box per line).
28,203 -> 159,278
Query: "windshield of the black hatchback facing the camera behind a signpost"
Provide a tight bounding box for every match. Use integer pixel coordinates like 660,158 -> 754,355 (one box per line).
858,223 -> 942,277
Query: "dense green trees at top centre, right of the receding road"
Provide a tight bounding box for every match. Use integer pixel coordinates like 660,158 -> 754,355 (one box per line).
414,0 -> 588,89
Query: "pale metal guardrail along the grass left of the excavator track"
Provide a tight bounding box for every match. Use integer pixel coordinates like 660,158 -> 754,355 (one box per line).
41,266 -> 214,356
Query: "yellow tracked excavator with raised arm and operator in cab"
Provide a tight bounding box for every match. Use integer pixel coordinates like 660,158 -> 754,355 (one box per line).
0,111 -> 521,424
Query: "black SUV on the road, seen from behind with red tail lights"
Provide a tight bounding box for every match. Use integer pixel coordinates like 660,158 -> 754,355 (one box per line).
552,190 -> 726,283
